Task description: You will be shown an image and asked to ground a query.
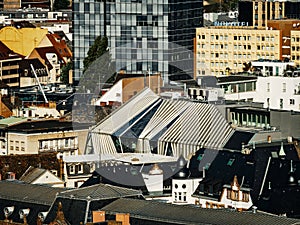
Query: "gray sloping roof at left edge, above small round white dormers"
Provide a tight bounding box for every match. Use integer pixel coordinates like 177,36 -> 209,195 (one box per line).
0,181 -> 61,206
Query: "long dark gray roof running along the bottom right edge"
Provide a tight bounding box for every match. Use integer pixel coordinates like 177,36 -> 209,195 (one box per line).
102,199 -> 300,225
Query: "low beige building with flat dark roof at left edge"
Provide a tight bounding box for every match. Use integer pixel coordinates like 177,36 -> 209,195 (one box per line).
0,119 -> 88,155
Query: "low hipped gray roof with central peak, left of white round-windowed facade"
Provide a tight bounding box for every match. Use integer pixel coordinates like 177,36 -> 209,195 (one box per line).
58,184 -> 142,201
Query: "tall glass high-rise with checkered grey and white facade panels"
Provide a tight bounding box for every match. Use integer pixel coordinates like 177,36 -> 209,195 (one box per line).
73,0 -> 203,82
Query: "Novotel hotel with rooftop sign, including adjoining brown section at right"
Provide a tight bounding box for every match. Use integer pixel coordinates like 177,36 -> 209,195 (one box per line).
195,19 -> 300,77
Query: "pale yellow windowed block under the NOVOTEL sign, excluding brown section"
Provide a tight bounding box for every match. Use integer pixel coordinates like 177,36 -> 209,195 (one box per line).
195,26 -> 281,77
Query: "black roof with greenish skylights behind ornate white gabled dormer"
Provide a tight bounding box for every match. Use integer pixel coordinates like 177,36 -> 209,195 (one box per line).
190,149 -> 258,200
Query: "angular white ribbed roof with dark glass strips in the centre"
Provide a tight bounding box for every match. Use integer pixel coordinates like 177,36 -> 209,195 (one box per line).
86,88 -> 234,158
